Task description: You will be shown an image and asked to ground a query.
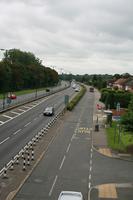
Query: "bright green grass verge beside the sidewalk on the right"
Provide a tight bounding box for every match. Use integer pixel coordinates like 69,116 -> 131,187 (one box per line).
106,123 -> 133,152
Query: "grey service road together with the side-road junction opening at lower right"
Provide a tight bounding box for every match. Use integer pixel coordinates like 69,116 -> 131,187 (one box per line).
11,88 -> 133,200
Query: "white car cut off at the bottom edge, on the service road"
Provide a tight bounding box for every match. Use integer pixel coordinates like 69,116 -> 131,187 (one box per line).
58,191 -> 83,200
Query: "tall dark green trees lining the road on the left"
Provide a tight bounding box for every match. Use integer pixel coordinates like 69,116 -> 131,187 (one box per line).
0,49 -> 59,93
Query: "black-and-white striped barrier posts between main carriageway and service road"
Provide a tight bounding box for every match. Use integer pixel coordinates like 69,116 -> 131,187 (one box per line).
0,108 -> 66,178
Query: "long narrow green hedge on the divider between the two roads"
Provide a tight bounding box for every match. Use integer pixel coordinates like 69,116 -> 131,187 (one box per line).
67,85 -> 86,111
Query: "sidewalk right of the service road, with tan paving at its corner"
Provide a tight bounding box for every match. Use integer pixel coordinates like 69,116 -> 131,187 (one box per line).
93,91 -> 133,162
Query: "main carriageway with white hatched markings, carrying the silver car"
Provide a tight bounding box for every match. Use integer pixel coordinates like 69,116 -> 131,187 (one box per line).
0,88 -> 75,169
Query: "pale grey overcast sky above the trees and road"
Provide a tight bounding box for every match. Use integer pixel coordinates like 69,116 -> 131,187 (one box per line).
0,0 -> 133,74
